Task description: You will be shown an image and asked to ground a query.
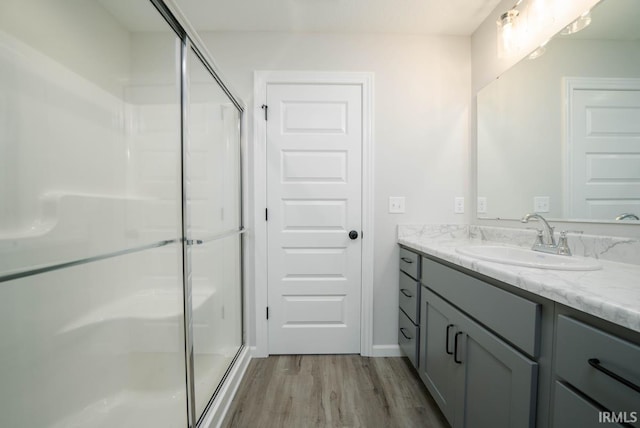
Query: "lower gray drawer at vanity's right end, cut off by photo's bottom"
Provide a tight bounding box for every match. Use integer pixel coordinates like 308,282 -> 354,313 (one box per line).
553,382 -> 621,428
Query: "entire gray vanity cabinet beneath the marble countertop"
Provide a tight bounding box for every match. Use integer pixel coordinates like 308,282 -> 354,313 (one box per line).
399,242 -> 640,428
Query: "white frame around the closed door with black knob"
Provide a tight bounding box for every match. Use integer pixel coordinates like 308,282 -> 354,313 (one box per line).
252,71 -> 374,357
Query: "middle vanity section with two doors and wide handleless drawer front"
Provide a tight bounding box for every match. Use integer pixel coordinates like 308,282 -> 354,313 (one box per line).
418,258 -> 539,428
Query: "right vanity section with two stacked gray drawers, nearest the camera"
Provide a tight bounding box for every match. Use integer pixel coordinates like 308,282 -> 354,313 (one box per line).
553,314 -> 640,428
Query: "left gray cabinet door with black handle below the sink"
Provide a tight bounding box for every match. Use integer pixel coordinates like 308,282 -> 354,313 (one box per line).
419,288 -> 458,424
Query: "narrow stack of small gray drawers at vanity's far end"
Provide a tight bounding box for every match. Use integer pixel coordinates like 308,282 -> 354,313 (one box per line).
398,248 -> 421,368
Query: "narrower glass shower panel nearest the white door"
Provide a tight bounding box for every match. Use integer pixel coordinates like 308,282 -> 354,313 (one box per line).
185,46 -> 243,419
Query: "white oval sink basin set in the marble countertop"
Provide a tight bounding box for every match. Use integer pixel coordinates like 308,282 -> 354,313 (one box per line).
456,245 -> 602,270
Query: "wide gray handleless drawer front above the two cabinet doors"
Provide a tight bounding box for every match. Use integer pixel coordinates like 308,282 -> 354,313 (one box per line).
422,257 -> 541,357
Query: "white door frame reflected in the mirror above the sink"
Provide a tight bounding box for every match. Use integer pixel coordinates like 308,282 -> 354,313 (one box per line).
562,77 -> 640,214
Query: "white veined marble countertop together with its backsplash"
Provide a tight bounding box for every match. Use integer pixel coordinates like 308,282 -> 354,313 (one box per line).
398,225 -> 640,332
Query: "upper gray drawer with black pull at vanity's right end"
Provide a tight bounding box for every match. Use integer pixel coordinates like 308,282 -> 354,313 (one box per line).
556,315 -> 640,426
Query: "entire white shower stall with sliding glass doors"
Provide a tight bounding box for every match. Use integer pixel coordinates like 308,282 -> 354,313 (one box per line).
0,0 -> 244,428
